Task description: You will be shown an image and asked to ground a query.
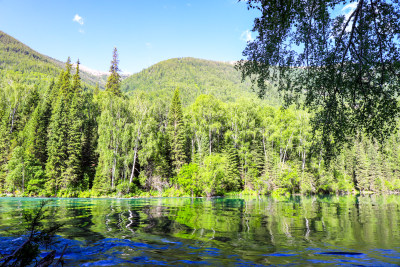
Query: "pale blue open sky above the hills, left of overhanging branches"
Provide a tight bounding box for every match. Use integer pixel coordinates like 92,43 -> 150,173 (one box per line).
0,0 -> 258,73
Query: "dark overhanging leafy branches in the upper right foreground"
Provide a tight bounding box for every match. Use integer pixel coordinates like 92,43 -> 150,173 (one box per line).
237,0 -> 400,159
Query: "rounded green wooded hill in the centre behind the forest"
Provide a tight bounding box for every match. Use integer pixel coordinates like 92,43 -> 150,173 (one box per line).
122,58 -> 277,105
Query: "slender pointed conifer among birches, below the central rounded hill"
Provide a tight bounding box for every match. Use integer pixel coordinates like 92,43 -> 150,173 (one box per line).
168,89 -> 186,174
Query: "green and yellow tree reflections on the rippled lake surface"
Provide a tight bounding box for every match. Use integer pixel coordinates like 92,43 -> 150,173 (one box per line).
0,196 -> 400,254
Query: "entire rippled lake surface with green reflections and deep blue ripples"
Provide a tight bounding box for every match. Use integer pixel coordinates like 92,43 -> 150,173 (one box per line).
0,195 -> 400,266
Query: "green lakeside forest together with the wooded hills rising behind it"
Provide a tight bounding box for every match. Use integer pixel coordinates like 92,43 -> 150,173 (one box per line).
0,32 -> 400,197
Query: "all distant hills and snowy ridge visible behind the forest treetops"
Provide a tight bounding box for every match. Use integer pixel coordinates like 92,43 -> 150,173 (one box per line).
0,31 -> 279,105
